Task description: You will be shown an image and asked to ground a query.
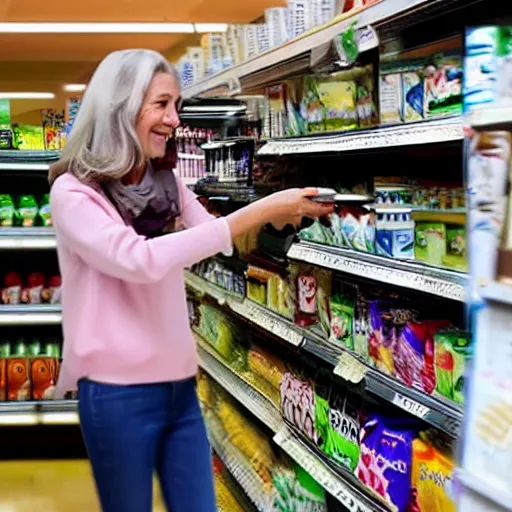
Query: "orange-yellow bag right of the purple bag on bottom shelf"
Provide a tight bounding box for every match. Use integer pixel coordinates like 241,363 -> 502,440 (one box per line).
412,439 -> 456,512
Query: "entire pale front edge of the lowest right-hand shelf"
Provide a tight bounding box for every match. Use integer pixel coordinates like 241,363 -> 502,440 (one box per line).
196,336 -> 392,512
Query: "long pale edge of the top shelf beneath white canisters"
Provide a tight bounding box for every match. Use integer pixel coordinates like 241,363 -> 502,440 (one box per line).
183,0 -> 464,98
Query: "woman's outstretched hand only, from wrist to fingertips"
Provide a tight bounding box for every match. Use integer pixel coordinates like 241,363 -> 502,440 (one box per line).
262,187 -> 334,229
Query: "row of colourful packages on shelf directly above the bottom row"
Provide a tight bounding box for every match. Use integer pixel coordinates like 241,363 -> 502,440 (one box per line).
190,251 -> 472,404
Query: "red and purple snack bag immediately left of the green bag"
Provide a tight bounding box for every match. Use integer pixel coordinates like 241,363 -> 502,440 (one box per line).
393,321 -> 450,395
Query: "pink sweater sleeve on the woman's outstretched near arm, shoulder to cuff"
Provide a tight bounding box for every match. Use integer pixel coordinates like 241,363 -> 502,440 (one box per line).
50,178 -> 232,283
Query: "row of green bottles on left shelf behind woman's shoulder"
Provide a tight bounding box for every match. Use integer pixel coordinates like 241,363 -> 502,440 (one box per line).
0,194 -> 52,227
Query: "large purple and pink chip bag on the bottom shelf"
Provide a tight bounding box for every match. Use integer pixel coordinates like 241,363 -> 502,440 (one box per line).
356,414 -> 416,512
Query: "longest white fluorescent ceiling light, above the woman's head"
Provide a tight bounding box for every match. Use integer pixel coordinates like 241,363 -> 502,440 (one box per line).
0,22 -> 195,34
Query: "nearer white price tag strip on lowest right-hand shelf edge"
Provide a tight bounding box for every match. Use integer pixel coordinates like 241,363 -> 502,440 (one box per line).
274,426 -> 391,512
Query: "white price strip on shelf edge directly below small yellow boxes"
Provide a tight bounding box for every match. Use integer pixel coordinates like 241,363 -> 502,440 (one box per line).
229,299 -> 304,347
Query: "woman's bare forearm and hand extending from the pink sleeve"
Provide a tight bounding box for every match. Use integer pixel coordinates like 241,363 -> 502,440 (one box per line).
226,187 -> 334,238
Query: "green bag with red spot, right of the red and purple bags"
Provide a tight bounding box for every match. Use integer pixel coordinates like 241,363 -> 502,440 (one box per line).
434,330 -> 472,404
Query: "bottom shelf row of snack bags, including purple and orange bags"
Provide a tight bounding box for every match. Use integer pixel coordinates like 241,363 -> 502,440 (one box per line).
196,324 -> 455,511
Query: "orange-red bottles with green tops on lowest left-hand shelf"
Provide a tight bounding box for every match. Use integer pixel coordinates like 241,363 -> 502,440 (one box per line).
0,339 -> 62,402
